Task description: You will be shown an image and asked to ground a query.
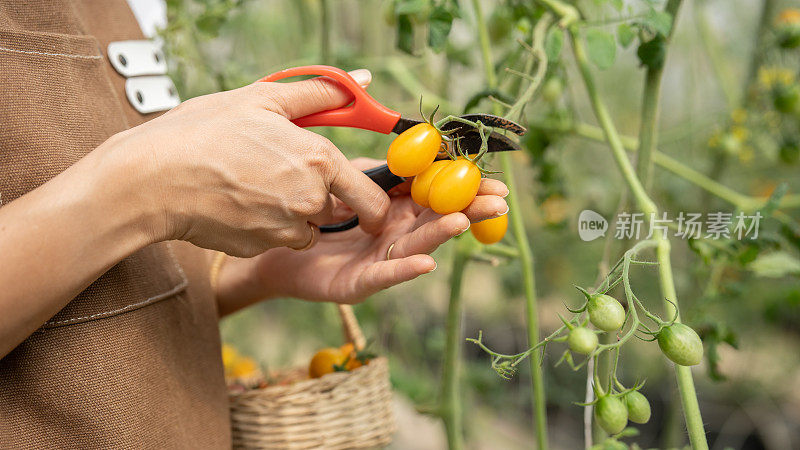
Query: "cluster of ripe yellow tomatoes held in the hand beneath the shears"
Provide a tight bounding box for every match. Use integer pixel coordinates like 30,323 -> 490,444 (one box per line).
386,122 -> 508,244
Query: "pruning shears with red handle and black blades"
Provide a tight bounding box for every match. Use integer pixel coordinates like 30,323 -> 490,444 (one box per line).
260,65 -> 527,233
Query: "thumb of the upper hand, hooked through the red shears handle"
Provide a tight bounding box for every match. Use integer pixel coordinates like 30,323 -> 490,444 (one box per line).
259,69 -> 372,120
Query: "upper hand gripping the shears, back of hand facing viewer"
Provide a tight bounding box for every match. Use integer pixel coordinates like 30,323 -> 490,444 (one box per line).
103,70 -> 389,256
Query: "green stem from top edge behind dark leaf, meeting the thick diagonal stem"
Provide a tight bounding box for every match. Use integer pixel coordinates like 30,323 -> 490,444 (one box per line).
636,0 -> 681,190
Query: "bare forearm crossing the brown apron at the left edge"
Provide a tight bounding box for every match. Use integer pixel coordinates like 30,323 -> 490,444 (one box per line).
0,138 -> 158,357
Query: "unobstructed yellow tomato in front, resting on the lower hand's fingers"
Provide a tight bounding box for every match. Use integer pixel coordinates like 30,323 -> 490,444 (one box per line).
428,159 -> 481,214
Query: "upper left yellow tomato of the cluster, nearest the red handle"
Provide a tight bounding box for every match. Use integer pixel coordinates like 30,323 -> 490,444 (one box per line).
386,122 -> 442,177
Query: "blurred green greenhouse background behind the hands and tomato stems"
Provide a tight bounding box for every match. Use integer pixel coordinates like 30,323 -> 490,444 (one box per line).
162,0 -> 800,449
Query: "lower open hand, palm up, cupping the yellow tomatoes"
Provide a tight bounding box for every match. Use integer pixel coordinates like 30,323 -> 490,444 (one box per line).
217,159 -> 508,315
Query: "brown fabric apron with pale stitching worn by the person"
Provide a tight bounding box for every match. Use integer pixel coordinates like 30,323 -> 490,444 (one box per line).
0,0 -> 230,448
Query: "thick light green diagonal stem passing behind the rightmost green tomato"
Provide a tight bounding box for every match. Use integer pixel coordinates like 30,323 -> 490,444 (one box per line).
569,27 -> 708,449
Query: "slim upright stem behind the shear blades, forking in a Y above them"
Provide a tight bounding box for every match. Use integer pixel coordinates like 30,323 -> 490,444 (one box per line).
472,0 -> 552,449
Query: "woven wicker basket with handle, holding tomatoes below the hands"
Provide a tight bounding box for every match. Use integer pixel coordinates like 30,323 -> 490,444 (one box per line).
230,305 -> 395,449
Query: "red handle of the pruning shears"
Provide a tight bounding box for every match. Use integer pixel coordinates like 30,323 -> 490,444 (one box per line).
260,66 -> 400,134
